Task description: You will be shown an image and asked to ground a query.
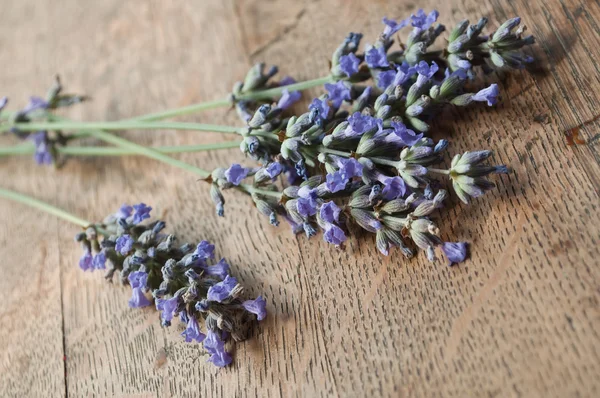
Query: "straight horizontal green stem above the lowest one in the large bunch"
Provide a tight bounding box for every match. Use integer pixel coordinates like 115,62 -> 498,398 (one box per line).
0,121 -> 239,134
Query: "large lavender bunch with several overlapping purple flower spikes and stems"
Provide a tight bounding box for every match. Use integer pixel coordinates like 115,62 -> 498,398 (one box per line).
3,10 -> 534,263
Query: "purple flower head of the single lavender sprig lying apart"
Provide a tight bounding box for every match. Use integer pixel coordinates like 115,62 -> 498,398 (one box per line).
75,203 -> 266,367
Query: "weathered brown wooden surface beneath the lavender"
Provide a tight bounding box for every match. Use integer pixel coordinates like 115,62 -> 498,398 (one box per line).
0,0 -> 600,397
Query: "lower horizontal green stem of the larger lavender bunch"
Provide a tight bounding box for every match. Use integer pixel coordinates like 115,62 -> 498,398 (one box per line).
0,141 -> 240,156
